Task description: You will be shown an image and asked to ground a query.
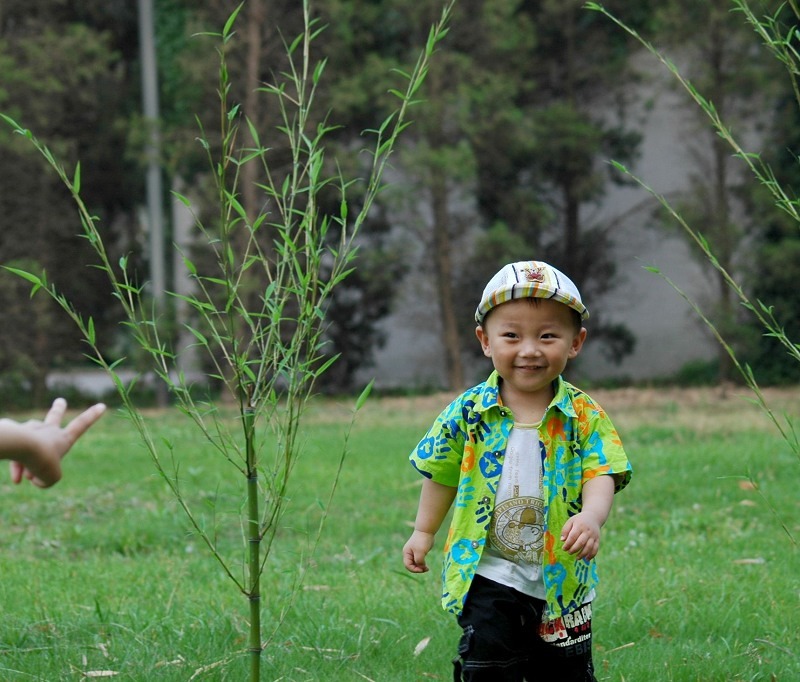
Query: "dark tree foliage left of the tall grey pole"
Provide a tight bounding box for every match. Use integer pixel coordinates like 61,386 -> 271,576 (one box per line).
0,0 -> 136,402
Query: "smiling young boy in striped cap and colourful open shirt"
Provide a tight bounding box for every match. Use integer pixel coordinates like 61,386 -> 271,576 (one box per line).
403,261 -> 631,682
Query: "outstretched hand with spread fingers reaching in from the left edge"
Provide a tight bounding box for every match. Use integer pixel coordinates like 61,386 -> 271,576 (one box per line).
0,398 -> 106,488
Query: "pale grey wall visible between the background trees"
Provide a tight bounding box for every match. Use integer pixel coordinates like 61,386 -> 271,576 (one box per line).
364,58 -> 717,388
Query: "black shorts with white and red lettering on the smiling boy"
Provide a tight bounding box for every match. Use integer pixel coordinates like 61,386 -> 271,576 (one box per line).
453,575 -> 596,682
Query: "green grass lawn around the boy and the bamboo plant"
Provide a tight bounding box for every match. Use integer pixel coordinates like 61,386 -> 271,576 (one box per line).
0,390 -> 800,682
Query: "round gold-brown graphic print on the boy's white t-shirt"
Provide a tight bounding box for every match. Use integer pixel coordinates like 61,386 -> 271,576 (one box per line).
489,497 -> 544,566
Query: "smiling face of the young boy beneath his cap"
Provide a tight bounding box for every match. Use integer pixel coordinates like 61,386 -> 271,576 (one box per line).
475,298 -> 586,402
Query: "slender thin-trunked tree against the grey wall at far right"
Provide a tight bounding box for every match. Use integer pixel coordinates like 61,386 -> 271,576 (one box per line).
654,0 -> 782,381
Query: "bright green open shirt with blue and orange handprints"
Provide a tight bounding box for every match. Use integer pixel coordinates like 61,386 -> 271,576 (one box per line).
410,372 -> 631,618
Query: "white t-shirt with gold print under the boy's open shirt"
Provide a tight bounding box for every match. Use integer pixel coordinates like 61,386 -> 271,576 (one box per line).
477,423 -> 545,599
